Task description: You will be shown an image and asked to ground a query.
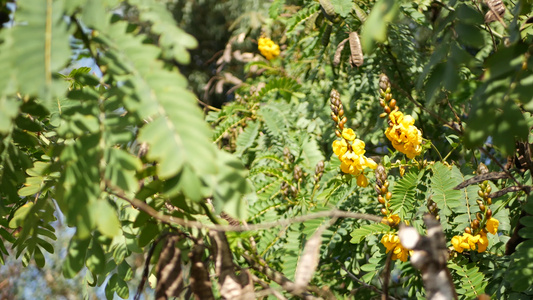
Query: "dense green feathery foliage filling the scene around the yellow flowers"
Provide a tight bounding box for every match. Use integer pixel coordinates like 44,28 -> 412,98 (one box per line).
0,0 -> 533,299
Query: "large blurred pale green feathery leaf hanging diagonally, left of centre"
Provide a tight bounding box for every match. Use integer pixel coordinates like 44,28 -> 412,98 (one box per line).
99,22 -> 215,179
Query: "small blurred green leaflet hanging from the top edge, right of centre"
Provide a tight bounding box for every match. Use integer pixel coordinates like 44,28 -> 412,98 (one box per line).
361,0 -> 399,53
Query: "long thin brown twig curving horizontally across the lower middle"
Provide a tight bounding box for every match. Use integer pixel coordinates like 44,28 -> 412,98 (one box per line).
108,185 -> 383,232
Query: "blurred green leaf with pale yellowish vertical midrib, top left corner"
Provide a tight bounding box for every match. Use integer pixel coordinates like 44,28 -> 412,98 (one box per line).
0,0 -> 71,100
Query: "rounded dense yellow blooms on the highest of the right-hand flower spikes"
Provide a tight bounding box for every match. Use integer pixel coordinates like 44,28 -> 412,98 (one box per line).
385,110 -> 422,158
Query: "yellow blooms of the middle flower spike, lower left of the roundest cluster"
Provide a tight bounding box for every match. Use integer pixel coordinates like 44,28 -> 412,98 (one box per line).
333,128 -> 378,187
